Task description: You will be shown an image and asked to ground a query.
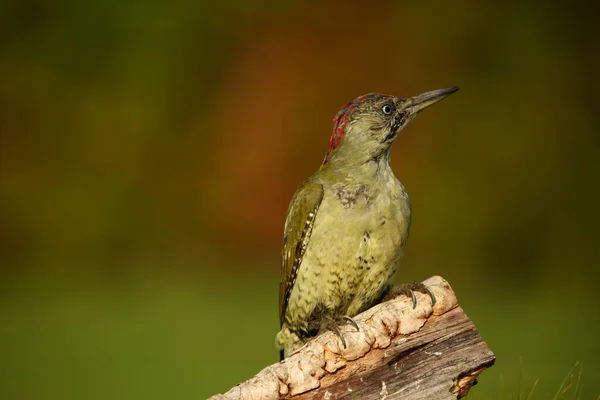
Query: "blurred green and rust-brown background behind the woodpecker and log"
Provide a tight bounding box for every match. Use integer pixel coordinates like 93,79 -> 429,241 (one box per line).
0,0 -> 600,400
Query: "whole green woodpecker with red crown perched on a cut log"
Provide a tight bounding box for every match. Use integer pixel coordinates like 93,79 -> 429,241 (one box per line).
275,86 -> 458,360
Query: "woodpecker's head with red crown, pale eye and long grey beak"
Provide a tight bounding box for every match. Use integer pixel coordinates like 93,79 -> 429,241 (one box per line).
323,87 -> 458,166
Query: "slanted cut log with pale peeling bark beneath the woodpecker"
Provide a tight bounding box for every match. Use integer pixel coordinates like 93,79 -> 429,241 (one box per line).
210,276 -> 495,400
